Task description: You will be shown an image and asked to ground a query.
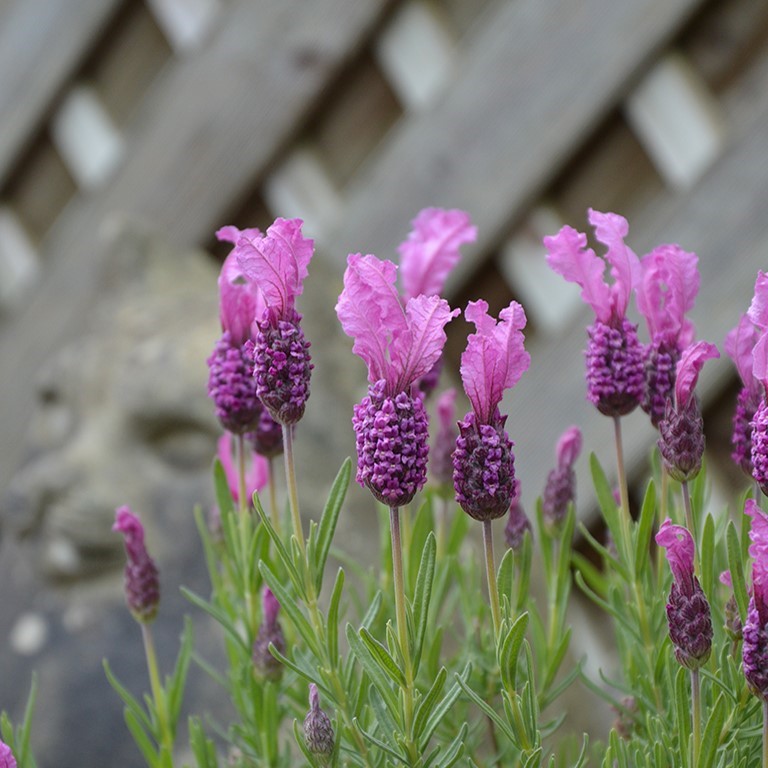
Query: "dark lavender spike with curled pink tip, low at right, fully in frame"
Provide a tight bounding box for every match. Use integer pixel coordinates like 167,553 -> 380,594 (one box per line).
656,518 -> 712,670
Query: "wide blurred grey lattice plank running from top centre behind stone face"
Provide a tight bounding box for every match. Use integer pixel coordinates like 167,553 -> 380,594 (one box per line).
0,0 -> 389,486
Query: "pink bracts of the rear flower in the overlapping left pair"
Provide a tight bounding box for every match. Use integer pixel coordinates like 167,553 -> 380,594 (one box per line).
216,226 -> 265,347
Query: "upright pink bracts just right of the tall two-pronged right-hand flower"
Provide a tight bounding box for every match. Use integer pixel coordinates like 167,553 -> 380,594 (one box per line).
636,245 -> 700,347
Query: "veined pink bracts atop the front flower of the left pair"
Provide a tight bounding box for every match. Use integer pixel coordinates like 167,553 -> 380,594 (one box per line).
236,219 -> 314,317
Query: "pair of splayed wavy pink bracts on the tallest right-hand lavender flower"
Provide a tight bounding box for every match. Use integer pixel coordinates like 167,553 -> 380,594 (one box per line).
544,208 -> 640,327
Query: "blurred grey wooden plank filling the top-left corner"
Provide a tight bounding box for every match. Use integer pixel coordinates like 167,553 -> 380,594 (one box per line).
0,0 -> 122,182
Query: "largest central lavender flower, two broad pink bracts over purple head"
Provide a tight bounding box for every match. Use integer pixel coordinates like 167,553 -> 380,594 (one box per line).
336,253 -> 458,507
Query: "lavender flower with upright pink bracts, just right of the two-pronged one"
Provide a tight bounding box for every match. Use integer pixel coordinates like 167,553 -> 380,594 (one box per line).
636,245 -> 700,427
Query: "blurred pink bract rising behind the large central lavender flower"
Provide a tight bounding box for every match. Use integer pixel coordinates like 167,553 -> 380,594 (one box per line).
398,208 -> 477,299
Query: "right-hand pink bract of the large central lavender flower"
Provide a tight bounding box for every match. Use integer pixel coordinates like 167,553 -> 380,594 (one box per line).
392,295 -> 460,392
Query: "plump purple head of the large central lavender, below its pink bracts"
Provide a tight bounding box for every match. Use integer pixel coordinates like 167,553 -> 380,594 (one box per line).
352,379 -> 429,507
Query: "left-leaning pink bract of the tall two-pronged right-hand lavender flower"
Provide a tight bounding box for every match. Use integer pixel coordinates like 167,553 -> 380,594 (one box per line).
544,226 -> 612,323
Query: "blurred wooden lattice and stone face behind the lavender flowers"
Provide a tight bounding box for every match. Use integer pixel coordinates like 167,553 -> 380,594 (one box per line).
0,0 -> 768,768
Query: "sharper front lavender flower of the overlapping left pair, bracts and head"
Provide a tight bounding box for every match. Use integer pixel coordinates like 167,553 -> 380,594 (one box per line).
235,219 -> 314,424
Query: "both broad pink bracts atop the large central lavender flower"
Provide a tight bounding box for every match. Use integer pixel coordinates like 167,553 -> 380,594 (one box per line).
336,253 -> 459,395
